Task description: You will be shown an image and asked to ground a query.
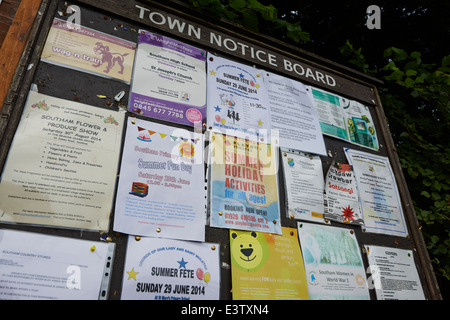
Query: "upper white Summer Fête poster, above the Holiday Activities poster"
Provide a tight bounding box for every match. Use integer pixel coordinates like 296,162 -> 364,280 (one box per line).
207,53 -> 270,143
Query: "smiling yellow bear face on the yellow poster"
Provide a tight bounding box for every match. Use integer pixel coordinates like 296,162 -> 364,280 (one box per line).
230,231 -> 269,271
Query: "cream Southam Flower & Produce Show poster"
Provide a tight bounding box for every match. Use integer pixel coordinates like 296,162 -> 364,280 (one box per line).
0,92 -> 124,231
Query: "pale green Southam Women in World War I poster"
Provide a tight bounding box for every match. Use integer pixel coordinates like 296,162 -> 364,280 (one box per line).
298,222 -> 370,300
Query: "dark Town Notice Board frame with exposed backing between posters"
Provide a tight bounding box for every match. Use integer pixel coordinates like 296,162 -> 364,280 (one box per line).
0,0 -> 441,300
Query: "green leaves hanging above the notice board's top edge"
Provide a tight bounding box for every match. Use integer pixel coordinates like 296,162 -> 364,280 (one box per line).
185,0 -> 310,43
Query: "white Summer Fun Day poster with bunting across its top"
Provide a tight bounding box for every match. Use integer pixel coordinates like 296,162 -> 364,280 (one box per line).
114,118 -> 206,241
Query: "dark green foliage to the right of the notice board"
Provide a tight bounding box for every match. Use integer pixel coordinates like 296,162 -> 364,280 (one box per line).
340,41 -> 450,280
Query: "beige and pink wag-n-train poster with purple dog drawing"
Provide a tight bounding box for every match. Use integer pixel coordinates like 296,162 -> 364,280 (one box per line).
41,18 -> 136,84
